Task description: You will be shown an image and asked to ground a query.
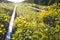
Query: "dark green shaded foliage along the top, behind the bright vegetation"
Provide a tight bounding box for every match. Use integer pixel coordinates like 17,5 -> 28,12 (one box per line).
25,0 -> 60,5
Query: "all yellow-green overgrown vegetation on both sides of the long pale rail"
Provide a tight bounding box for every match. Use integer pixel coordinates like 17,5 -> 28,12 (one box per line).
0,0 -> 60,40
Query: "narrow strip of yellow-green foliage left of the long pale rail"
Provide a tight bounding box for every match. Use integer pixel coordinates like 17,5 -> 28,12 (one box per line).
0,3 -> 12,40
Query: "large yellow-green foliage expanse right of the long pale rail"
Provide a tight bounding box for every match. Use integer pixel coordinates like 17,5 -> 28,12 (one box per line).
11,3 -> 60,40
